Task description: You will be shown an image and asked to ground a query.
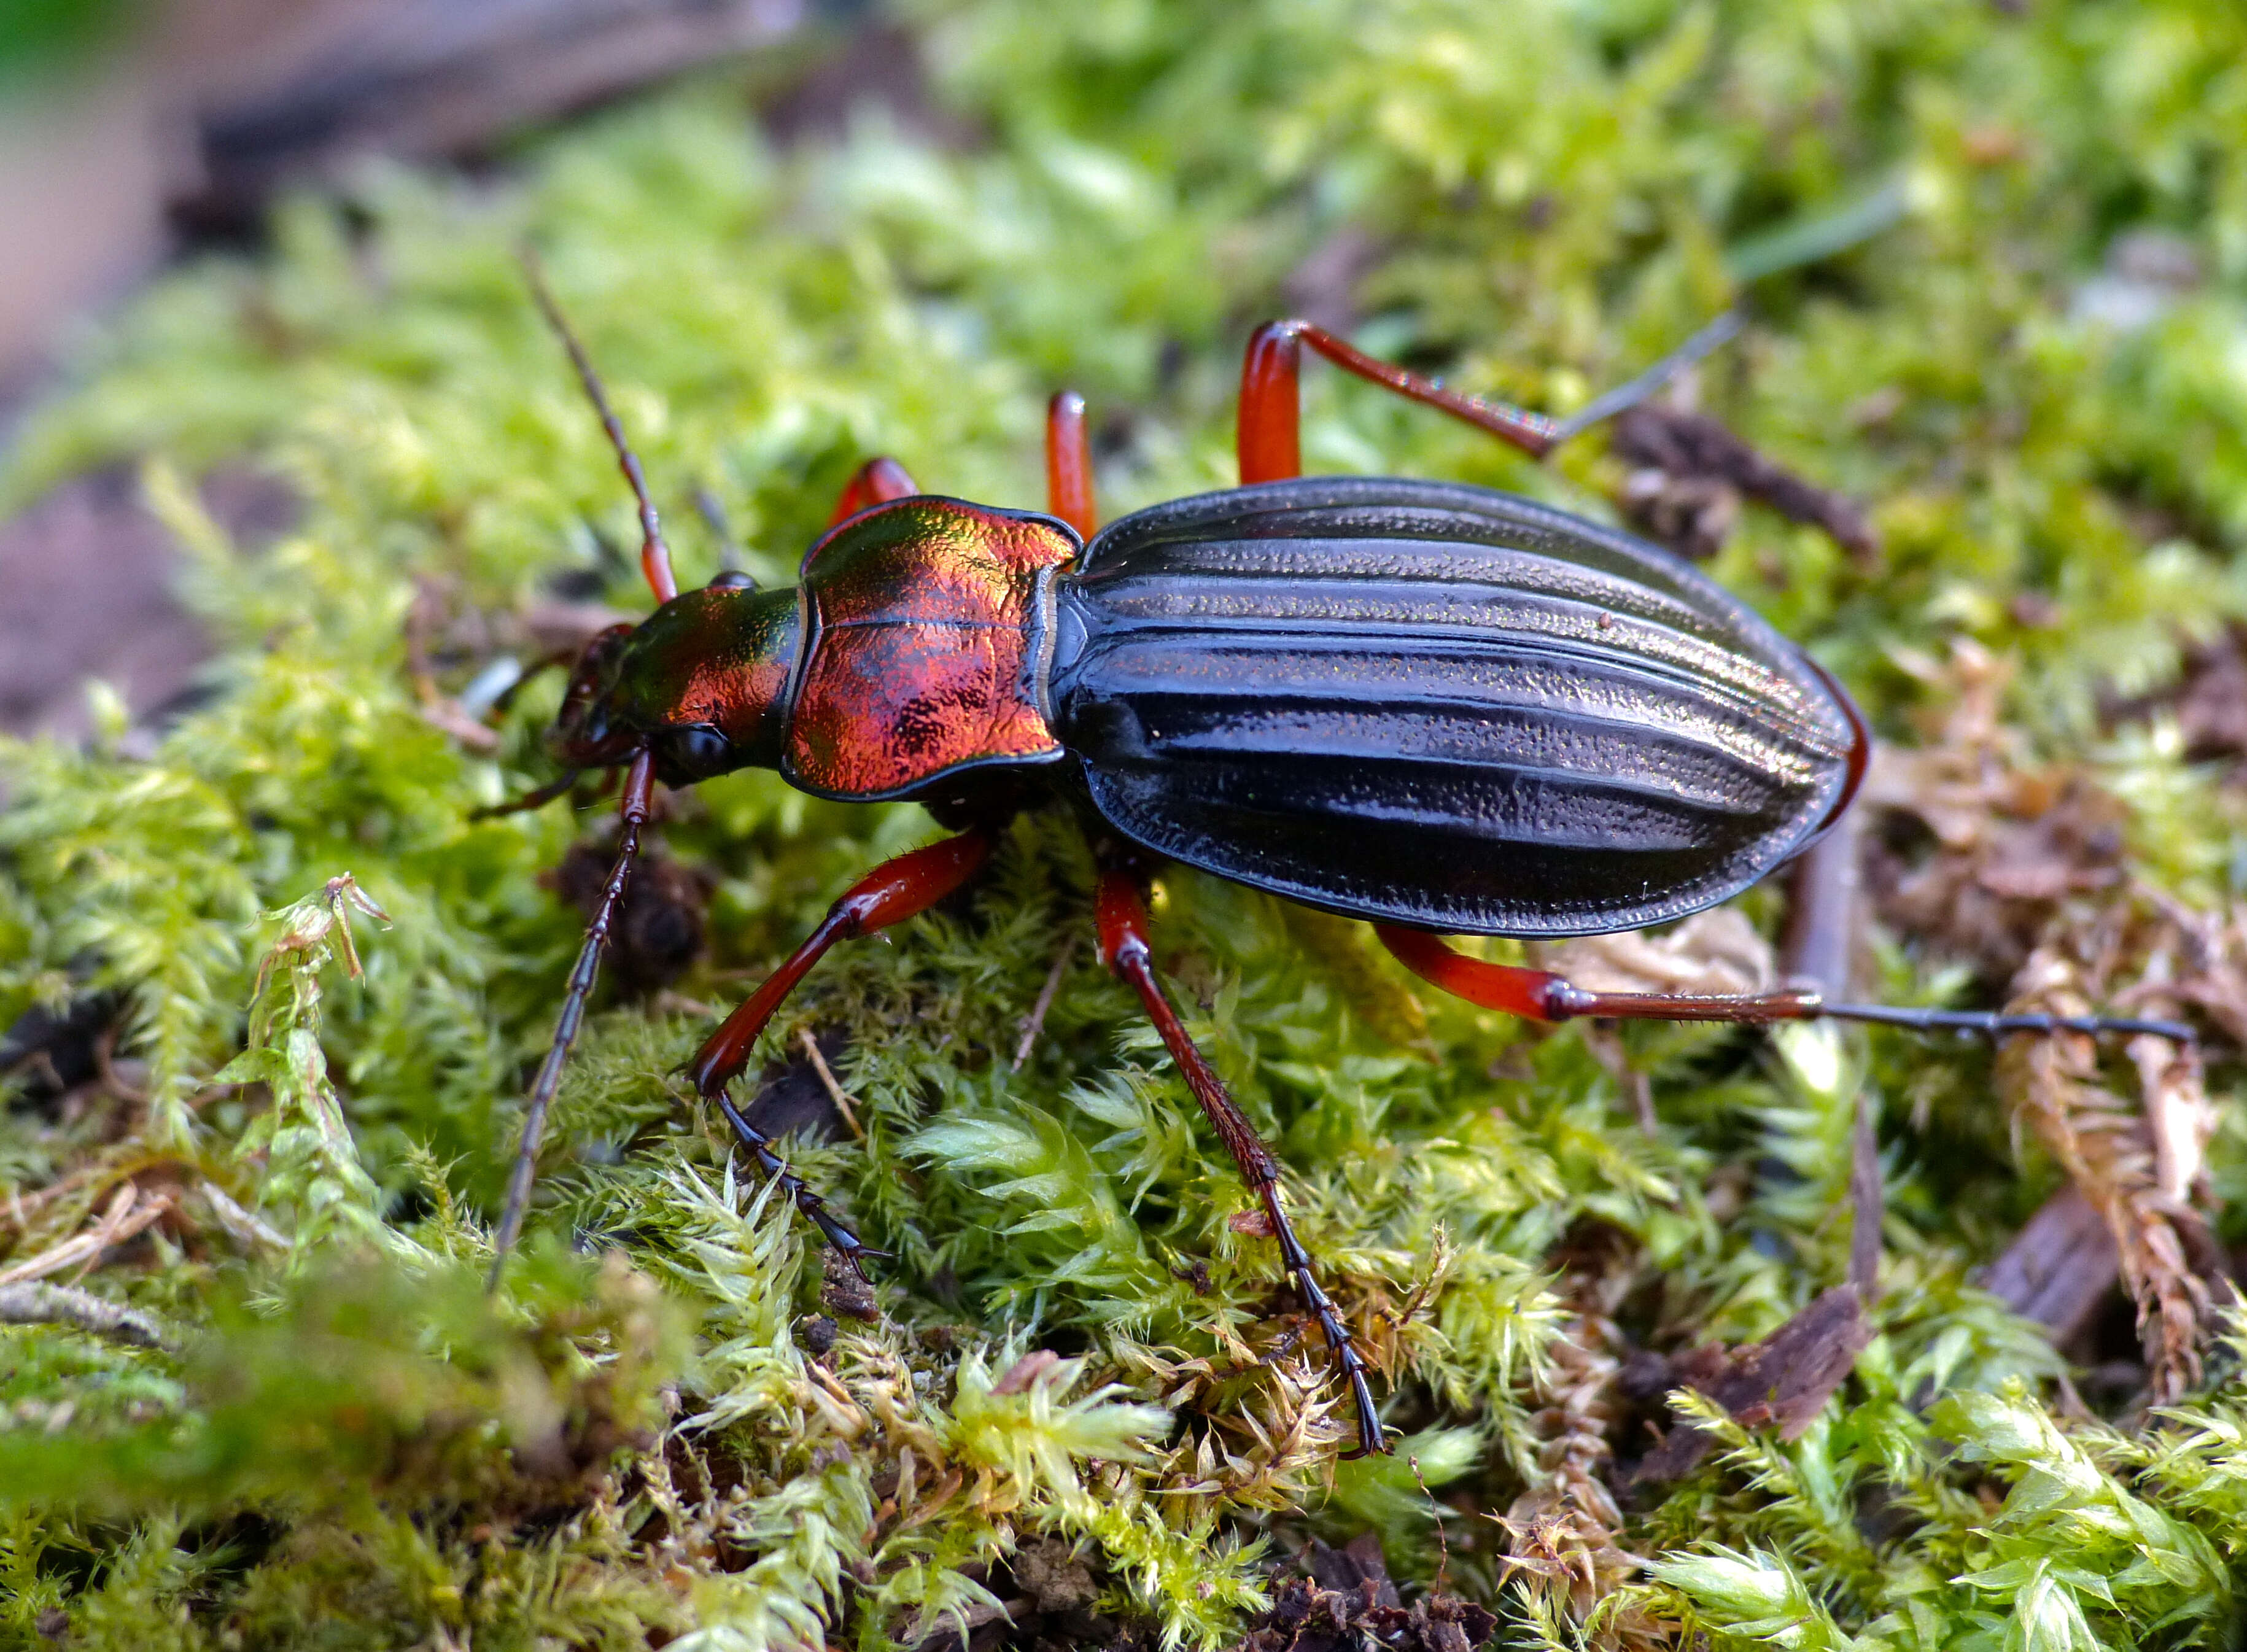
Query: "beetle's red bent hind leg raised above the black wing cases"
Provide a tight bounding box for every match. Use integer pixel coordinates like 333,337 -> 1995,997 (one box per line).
1238,310 -> 1742,487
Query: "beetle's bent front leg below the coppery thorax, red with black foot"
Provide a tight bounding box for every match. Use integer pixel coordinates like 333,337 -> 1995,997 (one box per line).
685,827 -> 991,1277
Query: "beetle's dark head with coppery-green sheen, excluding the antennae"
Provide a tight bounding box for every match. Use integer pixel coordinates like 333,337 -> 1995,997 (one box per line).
546,578 -> 802,786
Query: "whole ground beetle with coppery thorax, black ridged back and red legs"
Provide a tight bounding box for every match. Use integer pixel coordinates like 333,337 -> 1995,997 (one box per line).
494,268 -> 2191,1452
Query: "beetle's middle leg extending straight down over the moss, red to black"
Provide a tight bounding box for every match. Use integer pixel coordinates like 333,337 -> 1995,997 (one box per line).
1096,867 -> 1389,1456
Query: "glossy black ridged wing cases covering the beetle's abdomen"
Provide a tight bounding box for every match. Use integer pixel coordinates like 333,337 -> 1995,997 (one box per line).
1054,476 -> 1863,935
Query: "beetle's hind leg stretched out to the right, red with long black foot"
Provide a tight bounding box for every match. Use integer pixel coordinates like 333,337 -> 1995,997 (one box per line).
1373,924 -> 2195,1043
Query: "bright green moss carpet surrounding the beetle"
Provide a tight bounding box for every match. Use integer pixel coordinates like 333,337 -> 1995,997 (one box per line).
0,0 -> 2247,1652
